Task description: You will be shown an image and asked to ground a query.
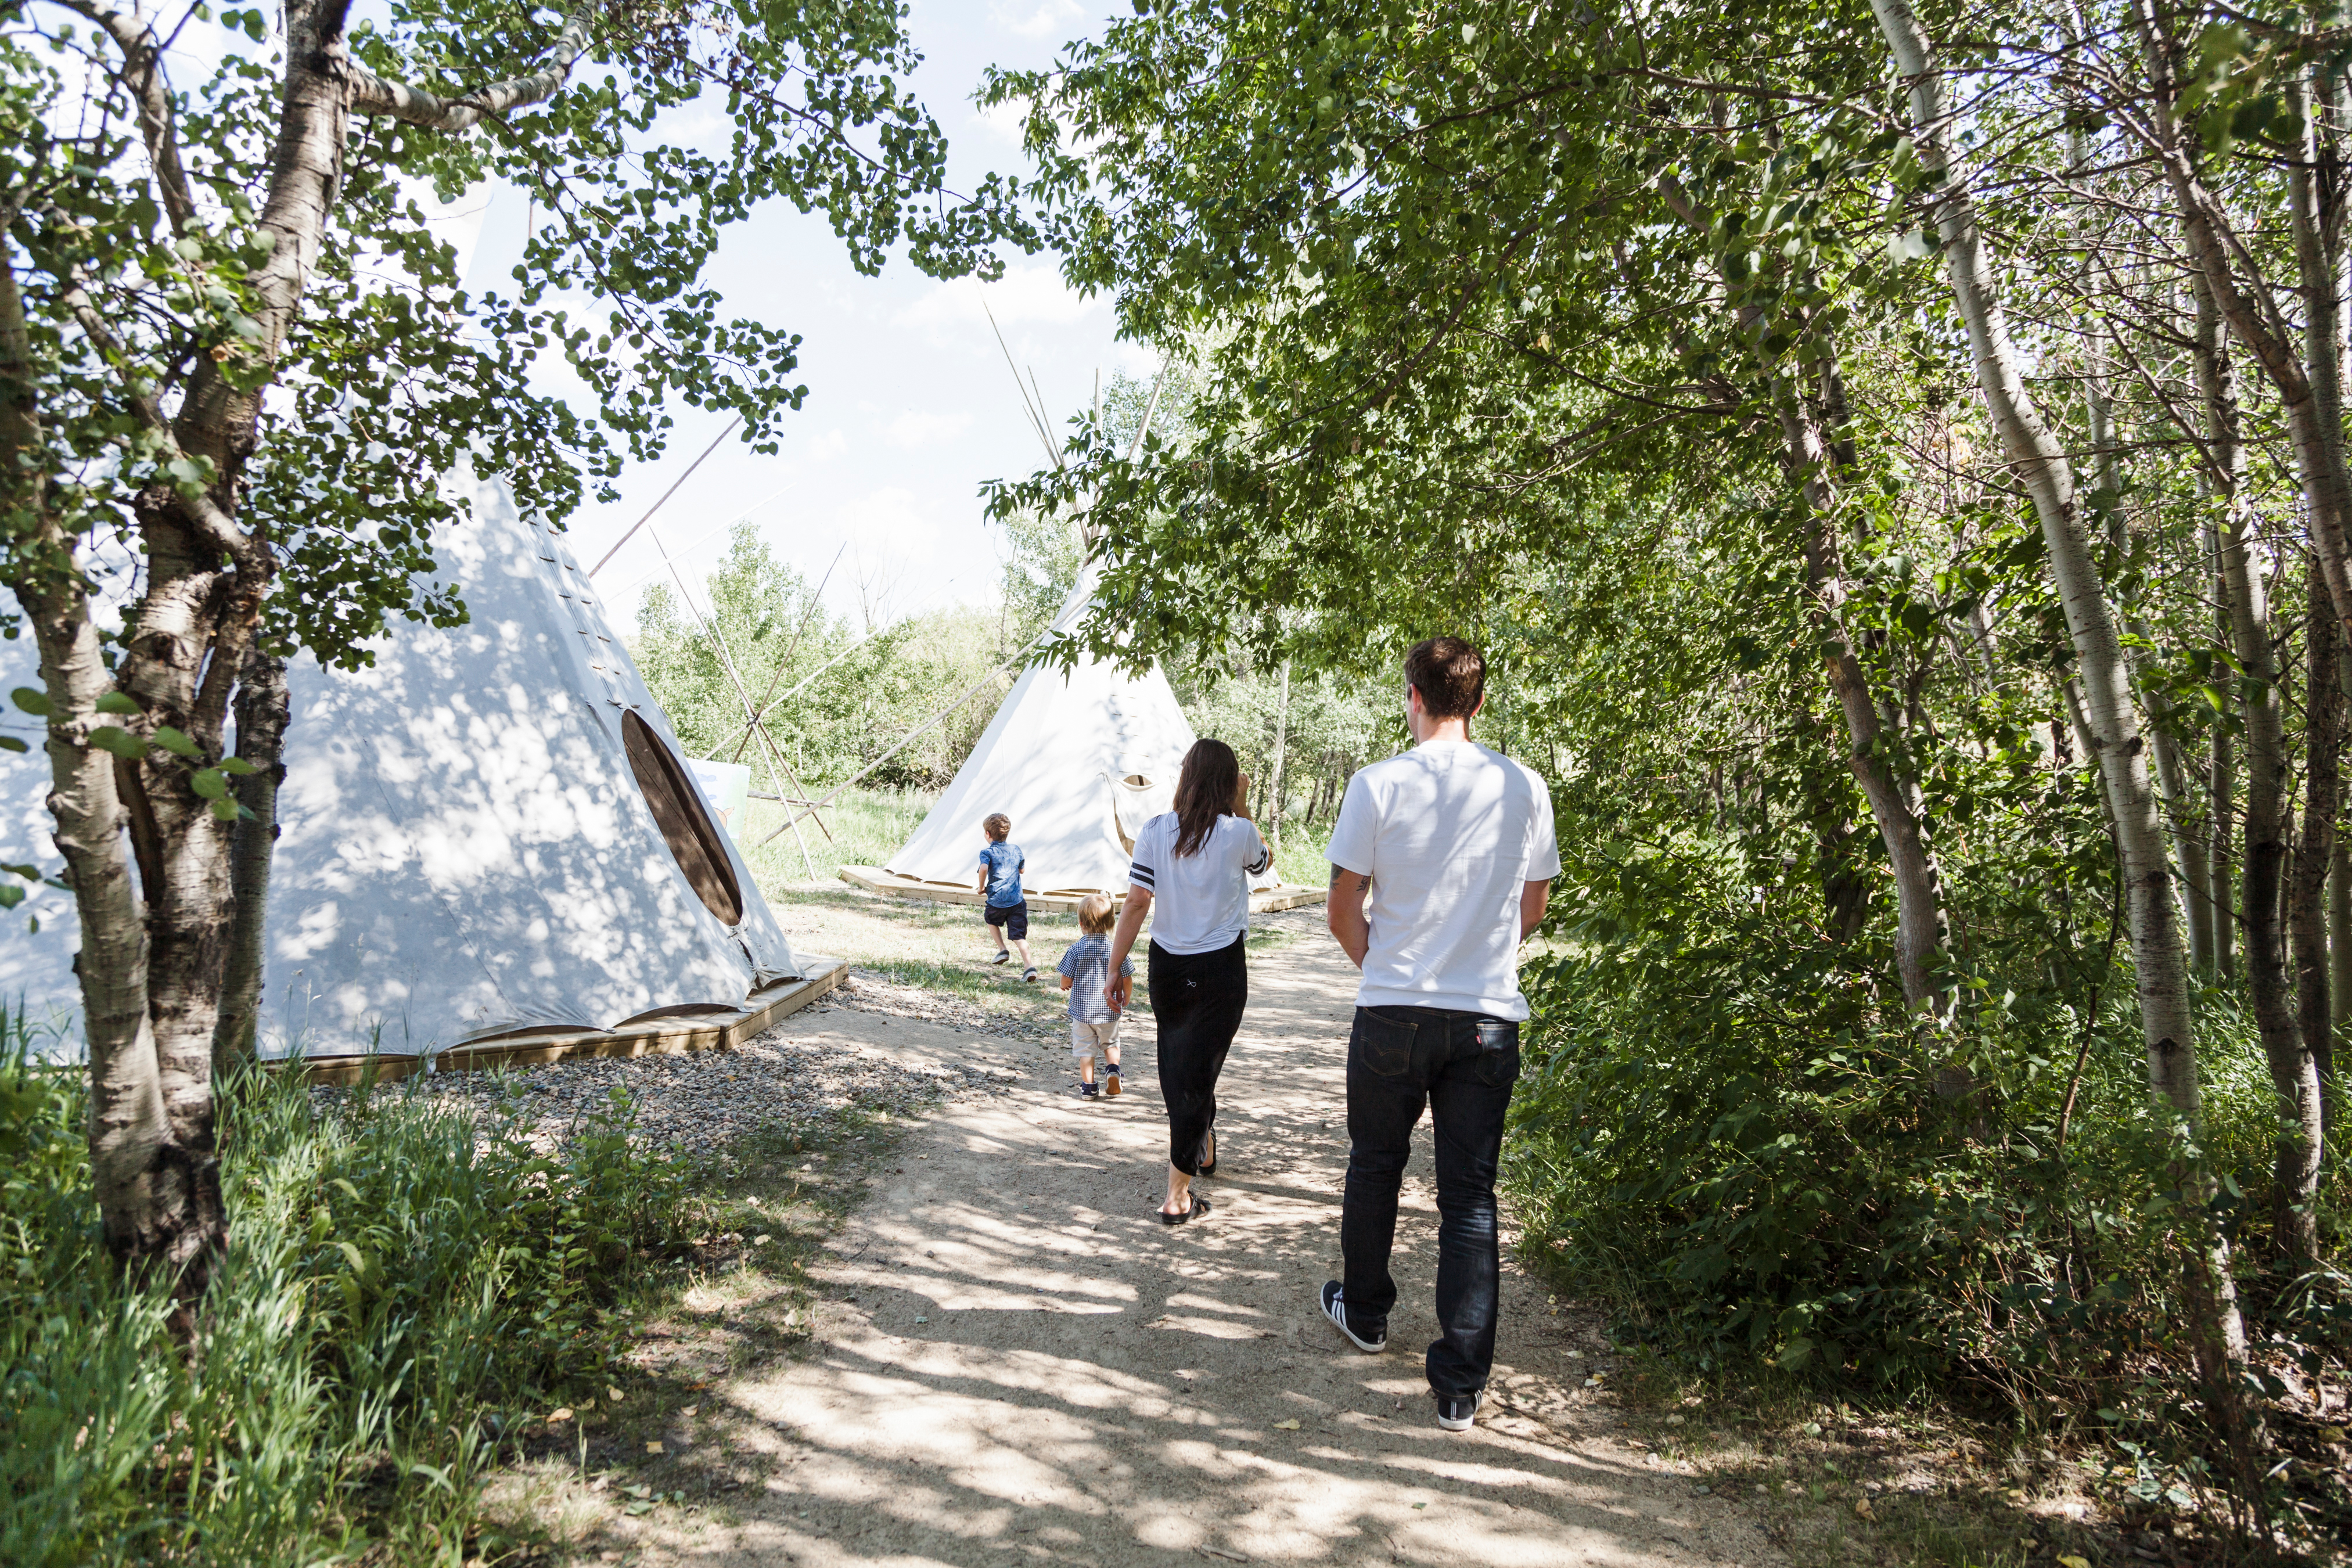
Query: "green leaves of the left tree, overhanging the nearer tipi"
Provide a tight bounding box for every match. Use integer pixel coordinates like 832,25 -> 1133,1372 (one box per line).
0,0 -> 1028,666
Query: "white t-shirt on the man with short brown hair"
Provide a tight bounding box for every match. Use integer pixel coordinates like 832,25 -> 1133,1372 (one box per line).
1324,740 -> 1559,1018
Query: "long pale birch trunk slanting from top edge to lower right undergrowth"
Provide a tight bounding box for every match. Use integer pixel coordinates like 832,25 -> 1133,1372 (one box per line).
1870,0 -> 2251,1419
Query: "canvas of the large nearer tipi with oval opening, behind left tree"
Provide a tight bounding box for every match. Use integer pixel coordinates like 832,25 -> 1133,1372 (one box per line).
0,480 -> 800,1056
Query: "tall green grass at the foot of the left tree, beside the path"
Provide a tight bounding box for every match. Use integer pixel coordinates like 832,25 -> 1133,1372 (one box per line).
0,1023 -> 694,1566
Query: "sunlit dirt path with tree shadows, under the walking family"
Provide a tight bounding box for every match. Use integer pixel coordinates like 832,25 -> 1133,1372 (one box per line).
632,922 -> 1781,1568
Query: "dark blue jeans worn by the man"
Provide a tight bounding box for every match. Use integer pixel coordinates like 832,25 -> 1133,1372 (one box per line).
1338,1006 -> 1519,1399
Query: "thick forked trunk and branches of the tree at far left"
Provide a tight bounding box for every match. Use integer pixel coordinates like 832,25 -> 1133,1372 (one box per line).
0,0 -> 595,1300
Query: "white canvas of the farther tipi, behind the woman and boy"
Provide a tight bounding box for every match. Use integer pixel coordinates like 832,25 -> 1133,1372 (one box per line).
884,571 -> 1192,896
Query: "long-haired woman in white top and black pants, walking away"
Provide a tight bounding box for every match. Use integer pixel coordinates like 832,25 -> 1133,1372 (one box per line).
1110,740 -> 1272,1225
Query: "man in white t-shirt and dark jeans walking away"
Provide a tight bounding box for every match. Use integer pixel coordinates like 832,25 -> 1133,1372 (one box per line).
1322,637 -> 1559,1432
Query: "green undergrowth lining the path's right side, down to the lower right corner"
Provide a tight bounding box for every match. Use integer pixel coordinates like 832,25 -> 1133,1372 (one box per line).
1505,835 -> 2352,1561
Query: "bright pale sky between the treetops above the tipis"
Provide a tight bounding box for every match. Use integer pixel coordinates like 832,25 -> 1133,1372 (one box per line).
456,0 -> 1138,628
